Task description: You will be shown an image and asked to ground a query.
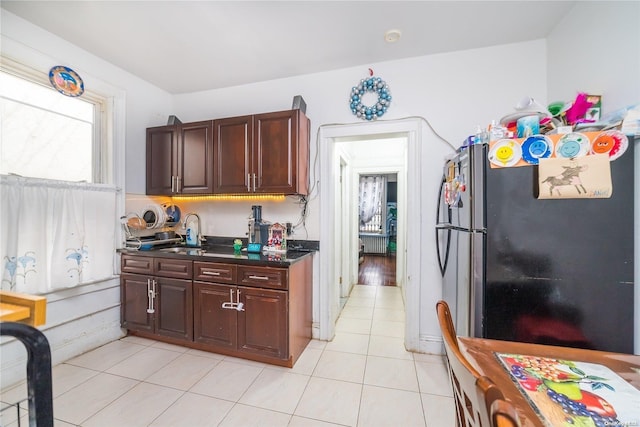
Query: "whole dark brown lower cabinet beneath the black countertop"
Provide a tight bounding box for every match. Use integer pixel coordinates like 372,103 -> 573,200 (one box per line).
120,254 -> 312,367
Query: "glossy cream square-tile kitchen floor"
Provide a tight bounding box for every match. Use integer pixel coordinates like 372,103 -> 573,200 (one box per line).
0,285 -> 455,427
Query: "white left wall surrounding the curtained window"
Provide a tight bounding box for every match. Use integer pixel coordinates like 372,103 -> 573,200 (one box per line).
0,9 -> 172,387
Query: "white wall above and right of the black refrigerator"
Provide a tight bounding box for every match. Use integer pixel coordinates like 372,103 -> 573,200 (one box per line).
547,1 -> 640,354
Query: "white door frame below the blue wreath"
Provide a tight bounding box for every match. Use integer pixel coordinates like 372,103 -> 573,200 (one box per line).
317,118 -> 422,351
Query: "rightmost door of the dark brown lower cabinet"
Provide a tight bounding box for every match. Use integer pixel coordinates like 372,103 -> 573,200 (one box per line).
238,286 -> 288,359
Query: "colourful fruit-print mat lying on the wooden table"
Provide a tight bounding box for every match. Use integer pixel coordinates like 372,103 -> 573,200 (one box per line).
496,353 -> 640,427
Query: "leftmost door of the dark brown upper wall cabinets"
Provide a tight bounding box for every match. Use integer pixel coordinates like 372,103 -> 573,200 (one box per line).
146,126 -> 178,195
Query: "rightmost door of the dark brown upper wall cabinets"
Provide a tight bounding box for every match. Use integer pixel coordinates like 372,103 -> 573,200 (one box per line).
252,110 -> 308,194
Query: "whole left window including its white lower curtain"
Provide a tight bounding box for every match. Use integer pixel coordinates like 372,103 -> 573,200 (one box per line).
0,58 -> 121,294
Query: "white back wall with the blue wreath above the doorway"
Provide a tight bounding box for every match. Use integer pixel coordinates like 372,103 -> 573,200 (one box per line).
168,40 -> 547,348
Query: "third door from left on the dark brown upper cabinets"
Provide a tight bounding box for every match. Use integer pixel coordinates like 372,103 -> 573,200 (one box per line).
213,116 -> 254,194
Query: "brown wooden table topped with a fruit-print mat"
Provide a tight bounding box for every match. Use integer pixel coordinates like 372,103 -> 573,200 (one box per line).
458,337 -> 640,427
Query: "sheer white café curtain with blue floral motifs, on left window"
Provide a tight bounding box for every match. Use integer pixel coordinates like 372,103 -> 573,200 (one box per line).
0,176 -> 117,294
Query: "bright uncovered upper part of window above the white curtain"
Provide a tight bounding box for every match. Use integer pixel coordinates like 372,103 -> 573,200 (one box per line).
0,66 -> 107,183
